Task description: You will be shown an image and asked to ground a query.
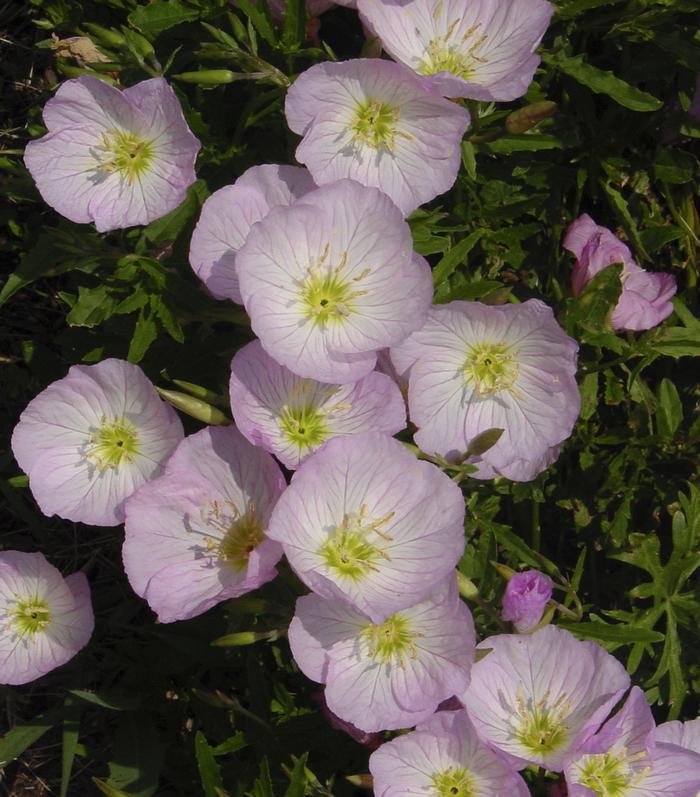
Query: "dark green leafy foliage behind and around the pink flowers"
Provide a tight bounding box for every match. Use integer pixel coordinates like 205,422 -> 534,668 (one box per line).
0,0 -> 700,797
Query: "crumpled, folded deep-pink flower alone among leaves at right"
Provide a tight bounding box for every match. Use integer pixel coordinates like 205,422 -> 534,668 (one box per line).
563,213 -> 676,332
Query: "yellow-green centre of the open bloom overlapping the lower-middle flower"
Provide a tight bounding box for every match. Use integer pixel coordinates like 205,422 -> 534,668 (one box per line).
319,505 -> 394,581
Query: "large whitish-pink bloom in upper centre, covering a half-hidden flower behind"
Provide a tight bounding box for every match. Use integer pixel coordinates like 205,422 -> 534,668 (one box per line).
236,180 -> 433,384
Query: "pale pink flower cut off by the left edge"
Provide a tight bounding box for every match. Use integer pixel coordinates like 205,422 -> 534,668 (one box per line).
0,551 -> 95,684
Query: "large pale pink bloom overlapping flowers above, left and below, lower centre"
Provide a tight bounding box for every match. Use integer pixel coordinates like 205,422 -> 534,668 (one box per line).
268,433 -> 464,620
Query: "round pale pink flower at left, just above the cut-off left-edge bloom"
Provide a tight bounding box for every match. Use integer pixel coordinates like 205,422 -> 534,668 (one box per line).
12,359 -> 183,526
